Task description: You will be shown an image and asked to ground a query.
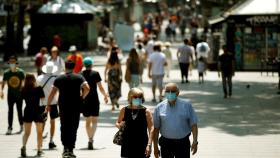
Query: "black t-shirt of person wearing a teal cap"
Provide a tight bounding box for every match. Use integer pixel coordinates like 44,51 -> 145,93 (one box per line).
82,70 -> 102,104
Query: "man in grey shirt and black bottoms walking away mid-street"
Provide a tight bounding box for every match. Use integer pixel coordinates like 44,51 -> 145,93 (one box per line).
177,39 -> 194,83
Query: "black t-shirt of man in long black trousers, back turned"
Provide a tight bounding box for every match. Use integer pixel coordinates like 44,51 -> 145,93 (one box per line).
53,73 -> 86,108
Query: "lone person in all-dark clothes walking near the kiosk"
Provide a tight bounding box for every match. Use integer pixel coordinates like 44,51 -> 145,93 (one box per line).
218,45 -> 235,98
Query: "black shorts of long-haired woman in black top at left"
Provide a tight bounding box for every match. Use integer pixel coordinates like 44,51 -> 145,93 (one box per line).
23,106 -> 45,123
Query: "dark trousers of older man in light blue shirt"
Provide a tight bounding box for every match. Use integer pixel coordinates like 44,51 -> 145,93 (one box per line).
159,135 -> 190,158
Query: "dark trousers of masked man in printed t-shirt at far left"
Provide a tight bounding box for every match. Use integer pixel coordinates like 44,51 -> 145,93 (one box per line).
8,94 -> 23,129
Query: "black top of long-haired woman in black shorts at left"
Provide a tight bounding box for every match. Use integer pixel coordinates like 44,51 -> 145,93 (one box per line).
22,86 -> 45,109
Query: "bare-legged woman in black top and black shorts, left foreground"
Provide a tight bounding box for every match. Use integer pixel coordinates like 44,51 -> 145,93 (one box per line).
21,74 -> 46,157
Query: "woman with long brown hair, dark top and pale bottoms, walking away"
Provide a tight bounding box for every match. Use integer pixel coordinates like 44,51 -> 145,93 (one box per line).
126,48 -> 141,88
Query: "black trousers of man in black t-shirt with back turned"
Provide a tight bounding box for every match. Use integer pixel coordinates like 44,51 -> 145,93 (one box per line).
60,110 -> 80,151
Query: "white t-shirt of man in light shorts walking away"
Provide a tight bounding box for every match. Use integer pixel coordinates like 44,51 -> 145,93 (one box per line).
149,52 -> 166,75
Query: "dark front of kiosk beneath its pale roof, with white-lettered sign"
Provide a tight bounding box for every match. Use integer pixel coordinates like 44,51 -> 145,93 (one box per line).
227,15 -> 280,70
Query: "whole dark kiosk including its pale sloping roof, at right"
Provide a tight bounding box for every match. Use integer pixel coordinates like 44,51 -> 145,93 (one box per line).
209,0 -> 280,70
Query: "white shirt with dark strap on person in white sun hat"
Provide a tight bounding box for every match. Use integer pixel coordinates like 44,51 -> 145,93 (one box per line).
37,74 -> 58,106
